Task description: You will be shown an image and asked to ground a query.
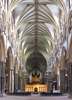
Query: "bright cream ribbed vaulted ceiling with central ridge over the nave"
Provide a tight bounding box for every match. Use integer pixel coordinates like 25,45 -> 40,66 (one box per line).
9,0 -> 66,74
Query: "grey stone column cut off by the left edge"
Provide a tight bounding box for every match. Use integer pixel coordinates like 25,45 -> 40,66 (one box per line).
0,61 -> 5,97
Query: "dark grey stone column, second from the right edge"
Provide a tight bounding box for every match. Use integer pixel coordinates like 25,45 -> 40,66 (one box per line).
60,69 -> 65,93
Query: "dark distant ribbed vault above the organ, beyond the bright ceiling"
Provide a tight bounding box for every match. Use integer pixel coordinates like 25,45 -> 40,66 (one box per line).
26,51 -> 47,73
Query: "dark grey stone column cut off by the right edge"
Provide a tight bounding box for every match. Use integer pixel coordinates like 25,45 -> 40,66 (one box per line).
68,62 -> 72,98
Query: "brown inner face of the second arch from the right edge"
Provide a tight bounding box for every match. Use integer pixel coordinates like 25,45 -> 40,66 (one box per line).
60,47 -> 67,70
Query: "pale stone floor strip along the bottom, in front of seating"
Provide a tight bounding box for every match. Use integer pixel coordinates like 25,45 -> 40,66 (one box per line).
0,95 -> 72,100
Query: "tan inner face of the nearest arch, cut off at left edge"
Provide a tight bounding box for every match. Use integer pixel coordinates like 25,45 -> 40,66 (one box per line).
0,31 -> 5,61
